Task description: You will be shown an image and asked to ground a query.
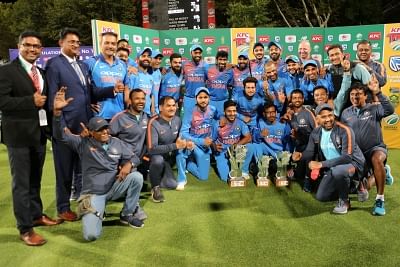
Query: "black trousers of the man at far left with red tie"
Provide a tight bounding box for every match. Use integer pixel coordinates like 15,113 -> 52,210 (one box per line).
7,145 -> 46,233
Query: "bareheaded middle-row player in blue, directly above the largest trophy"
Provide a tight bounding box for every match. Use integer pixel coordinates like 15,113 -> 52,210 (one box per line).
233,77 -> 264,130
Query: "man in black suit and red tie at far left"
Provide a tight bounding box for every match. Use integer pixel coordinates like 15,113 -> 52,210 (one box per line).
0,29 -> 61,246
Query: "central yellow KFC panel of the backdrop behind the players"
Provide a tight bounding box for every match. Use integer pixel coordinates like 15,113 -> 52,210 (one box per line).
231,28 -> 256,64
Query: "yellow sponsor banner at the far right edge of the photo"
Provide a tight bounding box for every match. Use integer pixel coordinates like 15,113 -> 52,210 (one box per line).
382,23 -> 400,148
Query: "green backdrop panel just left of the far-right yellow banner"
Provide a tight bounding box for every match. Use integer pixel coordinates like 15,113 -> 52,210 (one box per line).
324,24 -> 384,64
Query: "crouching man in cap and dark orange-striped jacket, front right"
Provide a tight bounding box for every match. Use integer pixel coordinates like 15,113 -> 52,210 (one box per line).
292,104 -> 365,214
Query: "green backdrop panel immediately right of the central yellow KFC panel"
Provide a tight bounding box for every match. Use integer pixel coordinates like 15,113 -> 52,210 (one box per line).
256,28 -> 324,65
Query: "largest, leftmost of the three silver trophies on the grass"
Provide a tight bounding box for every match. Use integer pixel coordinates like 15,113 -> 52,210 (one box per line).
228,145 -> 247,187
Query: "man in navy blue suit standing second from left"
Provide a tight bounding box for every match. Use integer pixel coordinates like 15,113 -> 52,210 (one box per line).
46,28 -> 92,221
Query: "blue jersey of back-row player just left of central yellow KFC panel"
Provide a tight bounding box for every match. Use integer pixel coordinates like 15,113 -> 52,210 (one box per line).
206,66 -> 233,101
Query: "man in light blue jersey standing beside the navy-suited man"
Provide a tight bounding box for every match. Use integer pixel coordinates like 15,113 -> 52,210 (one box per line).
85,32 -> 128,120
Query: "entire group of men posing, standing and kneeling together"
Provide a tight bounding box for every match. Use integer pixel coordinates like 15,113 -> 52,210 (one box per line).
0,28 -> 394,245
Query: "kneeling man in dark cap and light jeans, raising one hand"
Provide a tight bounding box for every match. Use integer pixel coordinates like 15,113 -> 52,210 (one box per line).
53,88 -> 144,241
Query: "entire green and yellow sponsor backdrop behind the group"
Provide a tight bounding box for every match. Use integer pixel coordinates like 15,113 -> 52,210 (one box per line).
92,20 -> 400,148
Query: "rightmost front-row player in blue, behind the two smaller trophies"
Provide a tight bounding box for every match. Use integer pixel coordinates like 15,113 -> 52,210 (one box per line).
253,103 -> 290,177
